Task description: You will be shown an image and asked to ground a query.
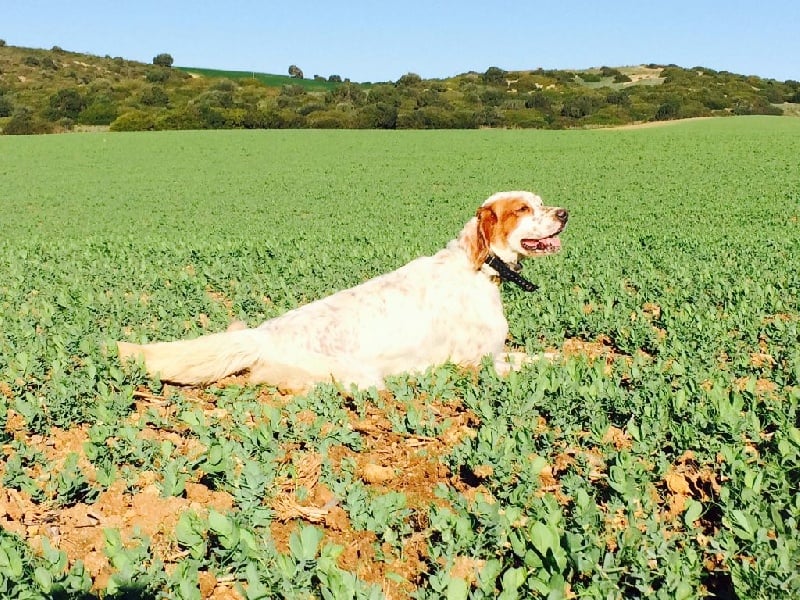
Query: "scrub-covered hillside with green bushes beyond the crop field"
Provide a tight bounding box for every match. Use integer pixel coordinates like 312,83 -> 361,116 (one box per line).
0,40 -> 800,134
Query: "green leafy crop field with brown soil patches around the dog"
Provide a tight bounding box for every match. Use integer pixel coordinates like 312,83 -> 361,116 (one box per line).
0,117 -> 800,600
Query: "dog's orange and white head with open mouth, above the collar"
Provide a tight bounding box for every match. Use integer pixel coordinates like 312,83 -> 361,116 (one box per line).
466,192 -> 569,268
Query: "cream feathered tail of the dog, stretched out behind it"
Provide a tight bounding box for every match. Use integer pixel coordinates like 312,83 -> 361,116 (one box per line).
117,329 -> 265,385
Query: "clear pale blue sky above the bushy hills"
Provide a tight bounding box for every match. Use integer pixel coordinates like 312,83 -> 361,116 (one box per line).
6,0 -> 800,81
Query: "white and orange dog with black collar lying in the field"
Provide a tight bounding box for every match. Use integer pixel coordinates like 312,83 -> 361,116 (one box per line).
117,191 -> 568,390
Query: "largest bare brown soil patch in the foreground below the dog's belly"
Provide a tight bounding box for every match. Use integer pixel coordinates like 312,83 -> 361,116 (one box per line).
271,396 -> 477,600
